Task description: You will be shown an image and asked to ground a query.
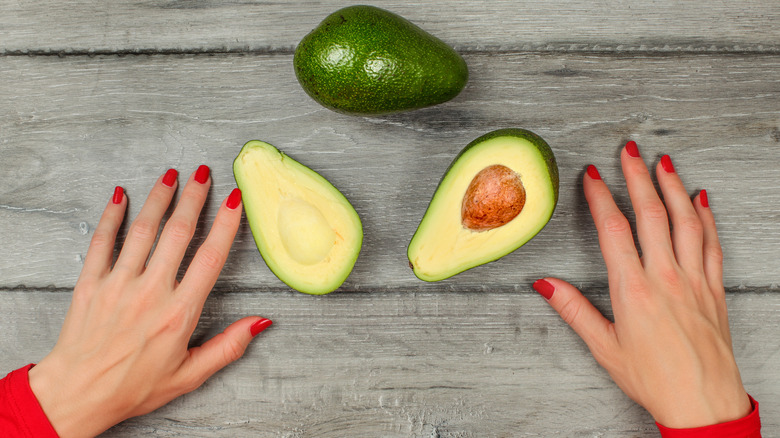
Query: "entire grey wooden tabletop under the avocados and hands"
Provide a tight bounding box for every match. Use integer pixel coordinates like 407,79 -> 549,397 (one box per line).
0,0 -> 780,437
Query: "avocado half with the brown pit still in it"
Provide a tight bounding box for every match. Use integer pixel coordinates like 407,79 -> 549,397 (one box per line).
407,129 -> 558,281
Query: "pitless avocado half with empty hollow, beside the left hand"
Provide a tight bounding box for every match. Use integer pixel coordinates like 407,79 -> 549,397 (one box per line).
233,140 -> 363,295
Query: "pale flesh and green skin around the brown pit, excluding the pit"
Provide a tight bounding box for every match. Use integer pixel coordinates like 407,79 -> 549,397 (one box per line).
407,129 -> 558,281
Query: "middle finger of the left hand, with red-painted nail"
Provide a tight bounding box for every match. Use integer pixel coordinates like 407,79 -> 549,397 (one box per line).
148,165 -> 211,283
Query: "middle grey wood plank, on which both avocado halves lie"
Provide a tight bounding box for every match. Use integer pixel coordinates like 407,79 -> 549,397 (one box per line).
0,53 -> 780,291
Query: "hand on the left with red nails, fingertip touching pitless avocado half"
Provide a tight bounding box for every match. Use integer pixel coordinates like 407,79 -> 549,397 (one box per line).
29,166 -> 271,438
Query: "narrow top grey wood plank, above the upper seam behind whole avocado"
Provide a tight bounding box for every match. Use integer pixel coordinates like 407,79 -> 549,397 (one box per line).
0,0 -> 780,54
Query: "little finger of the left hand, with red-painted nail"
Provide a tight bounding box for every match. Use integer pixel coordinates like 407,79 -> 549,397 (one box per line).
81,186 -> 127,278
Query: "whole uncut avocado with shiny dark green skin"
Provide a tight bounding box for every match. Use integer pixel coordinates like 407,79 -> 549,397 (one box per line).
293,6 -> 468,115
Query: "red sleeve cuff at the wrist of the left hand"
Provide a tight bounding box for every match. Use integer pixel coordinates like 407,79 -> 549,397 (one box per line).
0,364 -> 59,438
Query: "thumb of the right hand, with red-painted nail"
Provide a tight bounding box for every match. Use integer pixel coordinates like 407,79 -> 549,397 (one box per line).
533,278 -> 618,363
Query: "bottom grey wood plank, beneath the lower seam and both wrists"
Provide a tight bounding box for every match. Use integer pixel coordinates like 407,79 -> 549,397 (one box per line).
0,287 -> 780,437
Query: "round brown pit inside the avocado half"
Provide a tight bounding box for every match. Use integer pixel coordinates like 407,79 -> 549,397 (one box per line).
461,164 -> 525,231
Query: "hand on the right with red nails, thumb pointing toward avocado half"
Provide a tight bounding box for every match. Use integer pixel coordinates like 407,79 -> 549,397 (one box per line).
534,141 -> 751,428
